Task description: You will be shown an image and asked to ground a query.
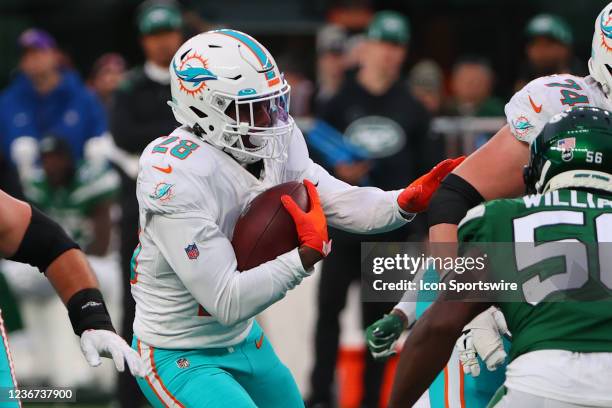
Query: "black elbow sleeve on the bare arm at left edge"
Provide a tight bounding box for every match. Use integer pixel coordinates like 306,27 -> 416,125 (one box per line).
7,206 -> 79,272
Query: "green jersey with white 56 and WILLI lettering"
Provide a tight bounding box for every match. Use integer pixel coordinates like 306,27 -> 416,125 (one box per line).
458,189 -> 612,360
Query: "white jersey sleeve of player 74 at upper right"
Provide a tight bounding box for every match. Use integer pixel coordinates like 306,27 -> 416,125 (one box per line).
505,74 -> 612,143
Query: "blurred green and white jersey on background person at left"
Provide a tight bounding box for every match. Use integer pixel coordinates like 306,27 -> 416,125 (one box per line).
23,162 -> 120,248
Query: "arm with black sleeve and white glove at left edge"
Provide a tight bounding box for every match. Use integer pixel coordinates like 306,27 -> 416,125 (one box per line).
0,191 -> 145,377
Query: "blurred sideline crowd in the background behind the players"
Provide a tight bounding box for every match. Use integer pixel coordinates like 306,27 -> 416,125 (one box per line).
0,0 -> 607,407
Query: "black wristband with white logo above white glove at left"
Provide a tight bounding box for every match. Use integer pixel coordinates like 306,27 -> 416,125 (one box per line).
66,288 -> 115,336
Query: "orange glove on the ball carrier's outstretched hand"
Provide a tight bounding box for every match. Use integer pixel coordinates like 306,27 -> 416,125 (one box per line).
397,156 -> 465,213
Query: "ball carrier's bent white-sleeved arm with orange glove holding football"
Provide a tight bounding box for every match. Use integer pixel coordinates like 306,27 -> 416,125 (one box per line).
150,180 -> 330,326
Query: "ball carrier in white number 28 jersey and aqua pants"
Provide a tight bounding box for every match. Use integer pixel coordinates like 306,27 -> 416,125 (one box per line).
132,30 -> 462,407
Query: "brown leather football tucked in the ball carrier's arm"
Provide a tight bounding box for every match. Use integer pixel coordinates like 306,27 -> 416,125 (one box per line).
232,181 -> 310,271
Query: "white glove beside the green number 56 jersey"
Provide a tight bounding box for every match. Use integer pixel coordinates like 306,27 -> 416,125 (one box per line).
456,306 -> 510,377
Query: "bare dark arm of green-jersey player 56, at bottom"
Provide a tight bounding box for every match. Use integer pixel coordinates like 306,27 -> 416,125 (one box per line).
389,301 -> 489,408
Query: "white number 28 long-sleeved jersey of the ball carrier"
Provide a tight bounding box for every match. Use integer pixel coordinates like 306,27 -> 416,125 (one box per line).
131,122 -> 408,349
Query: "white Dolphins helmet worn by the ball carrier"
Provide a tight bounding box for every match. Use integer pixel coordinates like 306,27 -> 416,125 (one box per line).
168,29 -> 294,163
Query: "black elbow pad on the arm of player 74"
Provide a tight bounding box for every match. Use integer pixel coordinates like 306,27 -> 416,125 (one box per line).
427,173 -> 484,227
